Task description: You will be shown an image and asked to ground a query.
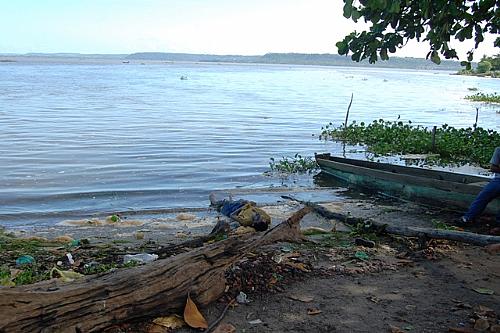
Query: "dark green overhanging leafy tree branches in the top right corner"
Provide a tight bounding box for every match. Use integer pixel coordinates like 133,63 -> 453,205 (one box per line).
336,0 -> 500,69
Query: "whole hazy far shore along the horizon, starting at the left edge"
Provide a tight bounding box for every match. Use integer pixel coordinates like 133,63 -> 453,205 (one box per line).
0,52 -> 462,71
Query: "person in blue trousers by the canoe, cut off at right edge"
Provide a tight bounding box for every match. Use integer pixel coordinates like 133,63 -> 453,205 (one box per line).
459,147 -> 500,226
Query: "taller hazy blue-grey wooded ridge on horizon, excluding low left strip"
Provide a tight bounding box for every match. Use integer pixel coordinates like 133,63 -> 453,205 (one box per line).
126,52 -> 462,71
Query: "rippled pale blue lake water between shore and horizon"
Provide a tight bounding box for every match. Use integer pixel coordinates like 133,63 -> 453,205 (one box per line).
0,63 -> 500,225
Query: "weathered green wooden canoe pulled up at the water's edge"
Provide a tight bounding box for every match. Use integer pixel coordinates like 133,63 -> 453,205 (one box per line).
316,154 -> 500,214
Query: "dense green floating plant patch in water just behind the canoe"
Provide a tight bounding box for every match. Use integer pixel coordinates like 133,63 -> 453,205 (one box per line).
320,119 -> 500,167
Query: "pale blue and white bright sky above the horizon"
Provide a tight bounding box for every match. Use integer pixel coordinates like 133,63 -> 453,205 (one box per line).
0,0 -> 498,57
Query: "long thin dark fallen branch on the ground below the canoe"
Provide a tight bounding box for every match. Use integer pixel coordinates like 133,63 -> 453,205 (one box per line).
283,196 -> 500,246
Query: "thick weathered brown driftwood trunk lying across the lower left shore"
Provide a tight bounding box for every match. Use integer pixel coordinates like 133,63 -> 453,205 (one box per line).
0,207 -> 310,332
